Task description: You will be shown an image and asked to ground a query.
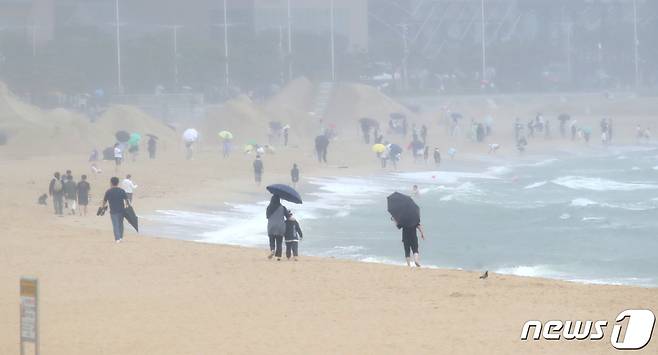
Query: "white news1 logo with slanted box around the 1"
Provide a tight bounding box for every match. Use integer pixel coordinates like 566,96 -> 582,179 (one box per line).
521,309 -> 656,350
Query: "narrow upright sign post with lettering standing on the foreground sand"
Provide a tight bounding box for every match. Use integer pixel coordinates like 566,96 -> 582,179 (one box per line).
20,277 -> 39,355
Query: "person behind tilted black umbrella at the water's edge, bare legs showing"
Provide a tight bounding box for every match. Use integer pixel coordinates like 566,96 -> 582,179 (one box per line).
387,192 -> 425,267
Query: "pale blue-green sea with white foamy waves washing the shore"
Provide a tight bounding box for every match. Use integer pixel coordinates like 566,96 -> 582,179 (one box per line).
147,147 -> 658,287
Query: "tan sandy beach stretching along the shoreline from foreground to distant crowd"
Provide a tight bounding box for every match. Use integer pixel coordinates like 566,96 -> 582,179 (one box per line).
0,117 -> 658,354
